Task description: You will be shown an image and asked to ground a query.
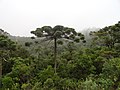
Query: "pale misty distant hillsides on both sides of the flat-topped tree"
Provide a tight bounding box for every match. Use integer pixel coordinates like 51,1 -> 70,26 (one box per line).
0,28 -> 99,49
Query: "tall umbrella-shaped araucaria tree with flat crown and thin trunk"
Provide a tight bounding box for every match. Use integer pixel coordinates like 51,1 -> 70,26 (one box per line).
31,25 -> 85,73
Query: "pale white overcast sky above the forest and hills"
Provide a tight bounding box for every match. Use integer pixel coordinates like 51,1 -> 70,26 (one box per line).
0,0 -> 120,36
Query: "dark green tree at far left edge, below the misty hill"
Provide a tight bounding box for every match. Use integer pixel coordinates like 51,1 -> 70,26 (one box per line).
0,35 -> 16,86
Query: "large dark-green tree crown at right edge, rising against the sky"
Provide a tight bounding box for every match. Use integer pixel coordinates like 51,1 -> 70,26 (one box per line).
90,22 -> 120,48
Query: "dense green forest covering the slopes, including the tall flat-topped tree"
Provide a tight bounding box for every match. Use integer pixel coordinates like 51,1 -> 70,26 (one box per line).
0,22 -> 120,90
